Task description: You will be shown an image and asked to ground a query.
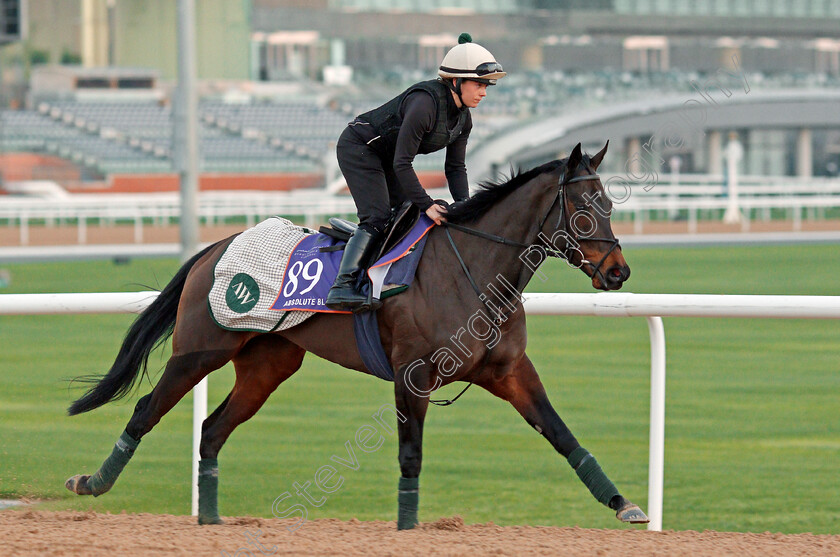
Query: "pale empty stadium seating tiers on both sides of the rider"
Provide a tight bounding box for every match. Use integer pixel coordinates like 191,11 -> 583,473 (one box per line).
0,69 -> 840,175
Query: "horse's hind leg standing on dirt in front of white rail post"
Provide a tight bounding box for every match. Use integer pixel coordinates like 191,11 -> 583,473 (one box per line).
198,335 -> 306,524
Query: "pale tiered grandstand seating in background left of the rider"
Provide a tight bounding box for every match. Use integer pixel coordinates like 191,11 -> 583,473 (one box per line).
0,94 -> 452,177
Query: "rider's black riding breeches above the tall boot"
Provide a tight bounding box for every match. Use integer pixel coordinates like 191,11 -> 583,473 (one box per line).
336,127 -> 405,233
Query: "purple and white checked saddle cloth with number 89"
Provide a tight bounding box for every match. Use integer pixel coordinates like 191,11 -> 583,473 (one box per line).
208,215 -> 434,332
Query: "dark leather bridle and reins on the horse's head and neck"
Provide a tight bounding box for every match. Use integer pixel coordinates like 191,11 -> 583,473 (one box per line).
443,167 -> 621,306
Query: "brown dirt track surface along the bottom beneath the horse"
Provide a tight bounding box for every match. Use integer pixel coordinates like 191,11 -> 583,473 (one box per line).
0,510 -> 840,557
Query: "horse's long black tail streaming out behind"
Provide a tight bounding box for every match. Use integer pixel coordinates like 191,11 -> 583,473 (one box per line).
67,244 -> 217,416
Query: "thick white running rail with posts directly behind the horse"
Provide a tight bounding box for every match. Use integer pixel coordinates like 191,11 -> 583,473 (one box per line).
0,291 -> 840,531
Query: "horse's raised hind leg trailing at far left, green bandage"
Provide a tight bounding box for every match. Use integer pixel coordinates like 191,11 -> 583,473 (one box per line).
65,344 -> 239,496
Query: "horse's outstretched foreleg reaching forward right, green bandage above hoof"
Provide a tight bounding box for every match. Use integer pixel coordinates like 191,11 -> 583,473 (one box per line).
479,355 -> 648,524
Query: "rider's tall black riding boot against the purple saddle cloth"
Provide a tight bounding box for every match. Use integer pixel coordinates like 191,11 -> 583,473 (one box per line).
326,228 -> 379,311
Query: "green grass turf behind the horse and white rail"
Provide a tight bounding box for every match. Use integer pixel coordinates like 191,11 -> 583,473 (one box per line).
0,245 -> 840,534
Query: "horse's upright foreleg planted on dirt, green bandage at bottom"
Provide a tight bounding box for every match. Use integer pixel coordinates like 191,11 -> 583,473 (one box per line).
394,366 -> 433,530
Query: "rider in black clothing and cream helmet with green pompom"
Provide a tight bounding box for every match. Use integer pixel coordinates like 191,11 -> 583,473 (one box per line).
326,33 -> 506,311
